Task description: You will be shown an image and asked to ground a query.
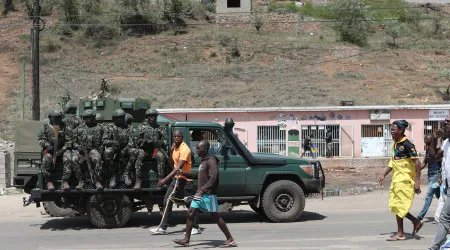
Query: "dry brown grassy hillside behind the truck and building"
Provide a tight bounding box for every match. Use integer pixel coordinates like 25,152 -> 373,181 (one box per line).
0,0 -> 450,139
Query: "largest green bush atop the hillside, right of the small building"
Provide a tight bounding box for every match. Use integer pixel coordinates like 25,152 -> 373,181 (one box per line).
331,0 -> 371,46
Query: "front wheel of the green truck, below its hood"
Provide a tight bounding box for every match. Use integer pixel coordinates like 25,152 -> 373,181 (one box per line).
262,180 -> 305,222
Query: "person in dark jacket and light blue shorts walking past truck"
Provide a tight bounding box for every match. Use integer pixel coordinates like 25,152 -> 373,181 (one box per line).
173,140 -> 237,247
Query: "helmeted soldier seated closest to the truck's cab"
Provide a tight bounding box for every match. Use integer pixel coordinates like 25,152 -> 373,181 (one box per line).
139,109 -> 168,180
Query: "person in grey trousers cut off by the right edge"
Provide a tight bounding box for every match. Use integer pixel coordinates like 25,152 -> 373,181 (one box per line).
429,116 -> 450,250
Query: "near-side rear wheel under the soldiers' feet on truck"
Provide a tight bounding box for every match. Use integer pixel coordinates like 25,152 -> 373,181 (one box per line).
87,194 -> 133,228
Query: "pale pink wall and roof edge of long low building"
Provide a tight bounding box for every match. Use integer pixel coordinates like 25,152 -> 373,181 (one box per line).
161,107 -> 449,157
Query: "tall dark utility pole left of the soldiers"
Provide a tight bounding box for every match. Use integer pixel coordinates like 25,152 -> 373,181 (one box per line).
31,0 -> 41,121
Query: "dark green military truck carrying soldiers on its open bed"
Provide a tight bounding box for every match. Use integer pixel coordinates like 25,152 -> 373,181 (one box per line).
14,100 -> 325,228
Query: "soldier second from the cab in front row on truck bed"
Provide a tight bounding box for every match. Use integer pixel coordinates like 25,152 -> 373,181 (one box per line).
122,114 -> 146,190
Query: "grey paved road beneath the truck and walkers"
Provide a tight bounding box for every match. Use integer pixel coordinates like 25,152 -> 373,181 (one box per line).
0,191 -> 442,250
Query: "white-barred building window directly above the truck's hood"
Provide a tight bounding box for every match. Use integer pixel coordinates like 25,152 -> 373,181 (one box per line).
256,126 -> 286,155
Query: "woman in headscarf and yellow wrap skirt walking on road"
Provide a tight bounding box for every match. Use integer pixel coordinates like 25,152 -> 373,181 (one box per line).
378,120 -> 423,241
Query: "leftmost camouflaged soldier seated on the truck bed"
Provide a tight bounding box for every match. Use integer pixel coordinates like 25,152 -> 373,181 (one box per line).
38,110 -> 65,190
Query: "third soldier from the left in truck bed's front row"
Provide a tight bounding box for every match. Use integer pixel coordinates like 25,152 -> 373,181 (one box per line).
74,109 -> 103,190
